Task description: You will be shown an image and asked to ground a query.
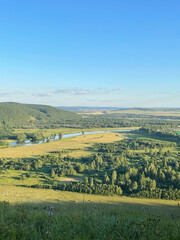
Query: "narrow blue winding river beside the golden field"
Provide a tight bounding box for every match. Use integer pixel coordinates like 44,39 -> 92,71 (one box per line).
9,129 -> 137,147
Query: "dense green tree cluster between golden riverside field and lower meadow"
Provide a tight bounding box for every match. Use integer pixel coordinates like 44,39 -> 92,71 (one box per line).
0,138 -> 180,199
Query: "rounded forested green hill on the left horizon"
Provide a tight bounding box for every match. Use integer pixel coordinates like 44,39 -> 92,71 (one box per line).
0,102 -> 81,127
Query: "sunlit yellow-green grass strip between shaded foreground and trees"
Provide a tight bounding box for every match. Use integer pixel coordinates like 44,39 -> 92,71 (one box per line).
0,186 -> 180,218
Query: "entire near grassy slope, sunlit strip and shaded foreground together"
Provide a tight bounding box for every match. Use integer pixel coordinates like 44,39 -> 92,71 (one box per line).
0,187 -> 180,240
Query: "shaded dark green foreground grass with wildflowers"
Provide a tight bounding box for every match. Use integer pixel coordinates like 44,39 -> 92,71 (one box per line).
0,200 -> 180,240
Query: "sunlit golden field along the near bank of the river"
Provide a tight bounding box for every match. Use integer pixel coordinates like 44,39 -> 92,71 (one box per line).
0,133 -> 127,158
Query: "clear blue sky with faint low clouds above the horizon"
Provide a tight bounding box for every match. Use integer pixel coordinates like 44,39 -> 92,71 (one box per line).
0,0 -> 180,107
